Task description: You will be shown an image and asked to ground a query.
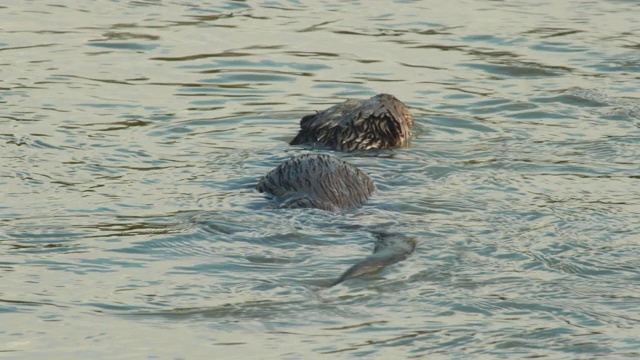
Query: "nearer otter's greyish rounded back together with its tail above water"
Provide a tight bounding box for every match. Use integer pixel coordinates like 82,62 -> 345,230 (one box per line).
257,154 -> 416,286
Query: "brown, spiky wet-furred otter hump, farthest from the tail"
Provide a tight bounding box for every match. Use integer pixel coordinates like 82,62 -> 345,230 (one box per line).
291,94 -> 413,151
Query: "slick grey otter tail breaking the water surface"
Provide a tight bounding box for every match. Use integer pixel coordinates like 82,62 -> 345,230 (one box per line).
330,233 -> 416,287
